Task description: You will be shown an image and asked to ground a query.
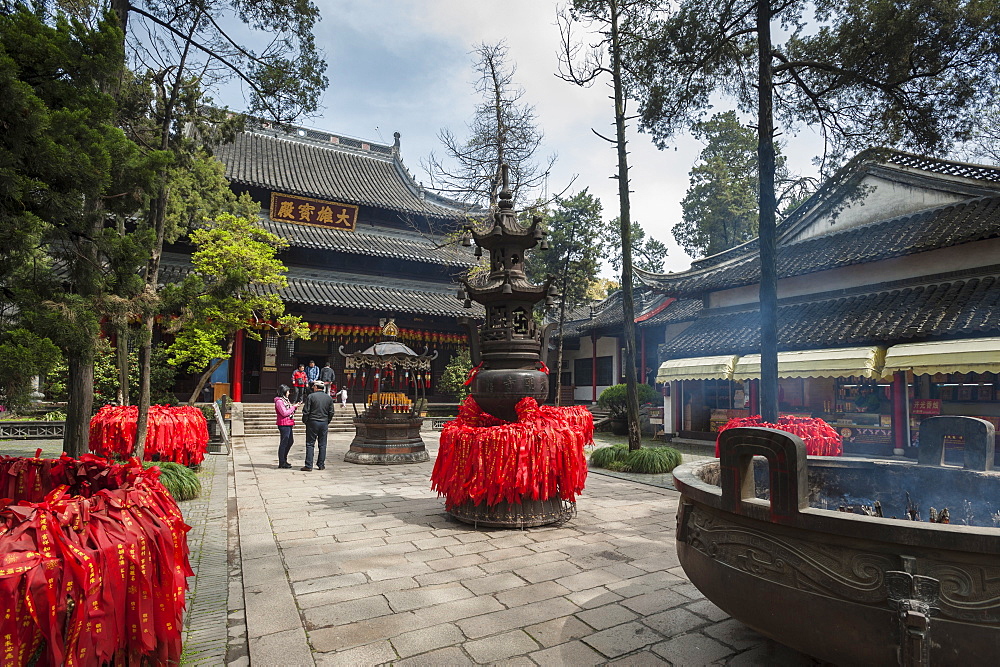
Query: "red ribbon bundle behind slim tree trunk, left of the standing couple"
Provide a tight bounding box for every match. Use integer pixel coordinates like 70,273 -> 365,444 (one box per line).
89,405 -> 208,465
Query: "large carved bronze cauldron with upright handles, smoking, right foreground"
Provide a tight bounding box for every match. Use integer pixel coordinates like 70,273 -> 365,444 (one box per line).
674,417 -> 1000,665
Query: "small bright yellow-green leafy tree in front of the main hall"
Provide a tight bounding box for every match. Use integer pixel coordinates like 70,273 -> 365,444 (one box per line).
164,213 -> 309,404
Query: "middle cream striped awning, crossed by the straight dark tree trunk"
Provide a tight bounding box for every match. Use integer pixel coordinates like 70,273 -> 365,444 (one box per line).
733,346 -> 885,380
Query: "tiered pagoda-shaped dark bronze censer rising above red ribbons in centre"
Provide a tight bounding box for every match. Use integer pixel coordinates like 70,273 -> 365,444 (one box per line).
459,165 -> 558,421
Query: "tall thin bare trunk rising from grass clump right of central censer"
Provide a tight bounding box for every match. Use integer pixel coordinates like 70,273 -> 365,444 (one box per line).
609,0 -> 642,450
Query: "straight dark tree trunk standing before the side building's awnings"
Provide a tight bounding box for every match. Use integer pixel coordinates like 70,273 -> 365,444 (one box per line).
757,0 -> 778,423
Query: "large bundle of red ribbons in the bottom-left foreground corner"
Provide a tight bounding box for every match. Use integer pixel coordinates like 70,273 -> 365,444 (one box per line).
0,454 -> 193,667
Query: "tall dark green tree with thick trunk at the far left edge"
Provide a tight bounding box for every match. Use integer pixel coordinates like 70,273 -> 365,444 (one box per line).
0,3 -> 148,455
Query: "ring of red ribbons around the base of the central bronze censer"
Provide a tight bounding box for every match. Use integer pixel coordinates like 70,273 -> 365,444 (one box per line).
431,396 -> 594,508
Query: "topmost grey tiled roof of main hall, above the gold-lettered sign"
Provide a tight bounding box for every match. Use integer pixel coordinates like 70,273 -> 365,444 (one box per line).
215,130 -> 476,219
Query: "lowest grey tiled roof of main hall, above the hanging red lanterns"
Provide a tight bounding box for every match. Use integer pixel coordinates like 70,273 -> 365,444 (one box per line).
160,254 -> 483,319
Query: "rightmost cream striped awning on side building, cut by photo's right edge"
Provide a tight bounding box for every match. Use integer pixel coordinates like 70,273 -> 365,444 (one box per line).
883,338 -> 1000,377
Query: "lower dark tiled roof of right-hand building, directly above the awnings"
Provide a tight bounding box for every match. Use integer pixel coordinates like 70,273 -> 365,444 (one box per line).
661,275 -> 1000,358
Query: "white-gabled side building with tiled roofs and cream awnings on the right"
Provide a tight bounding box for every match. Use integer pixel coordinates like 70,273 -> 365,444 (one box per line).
637,150 -> 1000,455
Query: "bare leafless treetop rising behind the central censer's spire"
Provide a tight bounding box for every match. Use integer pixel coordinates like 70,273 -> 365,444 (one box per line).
423,41 -> 556,206
